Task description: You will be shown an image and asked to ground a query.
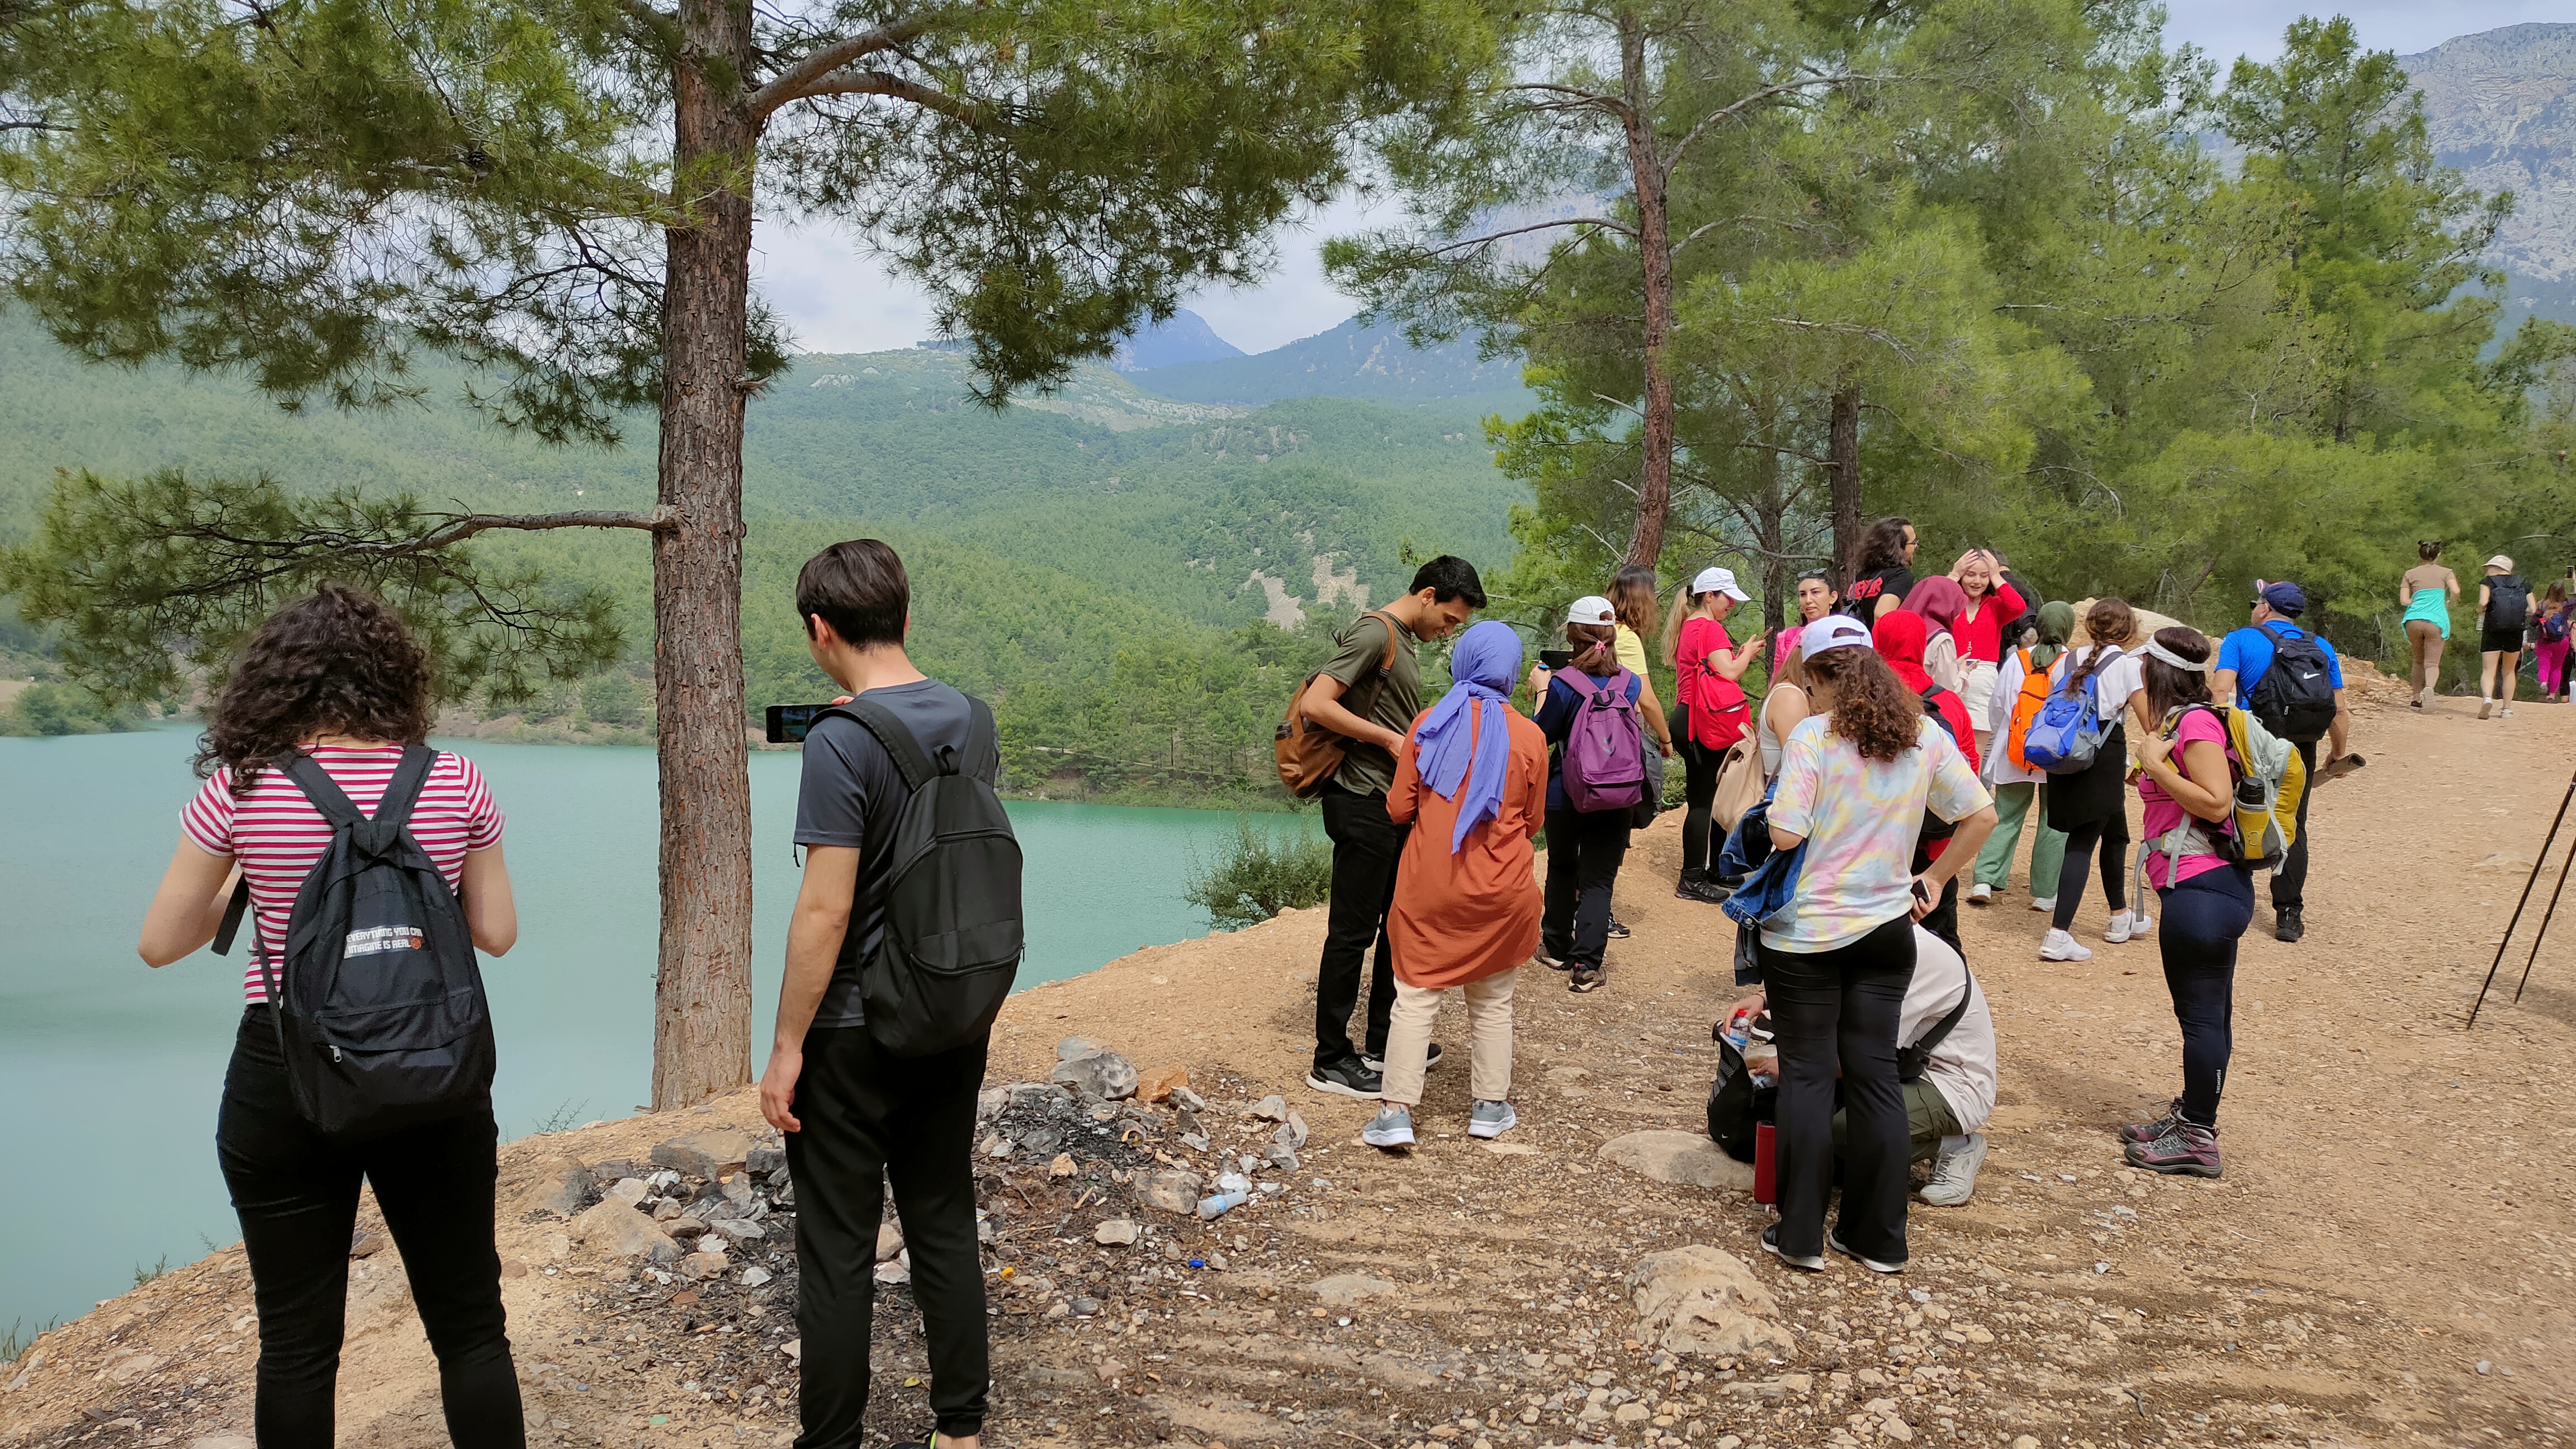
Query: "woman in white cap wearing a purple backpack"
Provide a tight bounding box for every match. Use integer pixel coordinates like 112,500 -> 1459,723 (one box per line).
1530,593 -> 1651,993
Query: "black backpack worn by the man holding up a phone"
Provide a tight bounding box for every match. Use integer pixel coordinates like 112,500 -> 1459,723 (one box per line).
817,696 -> 1025,1057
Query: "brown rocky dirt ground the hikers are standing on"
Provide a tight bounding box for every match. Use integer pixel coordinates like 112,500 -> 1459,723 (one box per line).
0,670 -> 2576,1449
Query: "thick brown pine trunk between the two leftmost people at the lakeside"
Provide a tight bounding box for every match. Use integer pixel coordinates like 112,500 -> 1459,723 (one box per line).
652,0 -> 757,1111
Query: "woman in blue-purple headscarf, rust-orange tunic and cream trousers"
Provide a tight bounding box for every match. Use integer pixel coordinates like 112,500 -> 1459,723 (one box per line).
1360,622 -> 1548,1147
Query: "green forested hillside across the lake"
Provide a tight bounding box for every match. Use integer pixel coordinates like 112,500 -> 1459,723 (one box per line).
0,317 -> 1525,799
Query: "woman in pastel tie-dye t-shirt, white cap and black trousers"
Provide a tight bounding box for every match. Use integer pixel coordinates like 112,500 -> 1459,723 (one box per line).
1759,614 -> 1994,1273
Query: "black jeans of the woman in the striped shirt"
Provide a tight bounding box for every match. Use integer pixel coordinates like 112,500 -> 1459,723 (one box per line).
214,1006 -> 528,1449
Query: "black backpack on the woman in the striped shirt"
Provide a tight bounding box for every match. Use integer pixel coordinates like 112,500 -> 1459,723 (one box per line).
214,745 -> 492,1142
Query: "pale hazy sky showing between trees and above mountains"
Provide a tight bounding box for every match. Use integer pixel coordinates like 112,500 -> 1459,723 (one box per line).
755,0 -> 2571,353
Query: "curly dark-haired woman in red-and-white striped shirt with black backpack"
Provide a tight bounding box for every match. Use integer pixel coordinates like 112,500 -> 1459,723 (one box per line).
139,583 -> 525,1449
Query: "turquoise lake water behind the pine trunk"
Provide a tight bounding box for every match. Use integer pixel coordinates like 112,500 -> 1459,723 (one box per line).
0,727 -> 1293,1333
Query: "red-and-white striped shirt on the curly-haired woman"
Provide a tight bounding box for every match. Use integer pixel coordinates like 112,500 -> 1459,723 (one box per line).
181,745 -> 503,1003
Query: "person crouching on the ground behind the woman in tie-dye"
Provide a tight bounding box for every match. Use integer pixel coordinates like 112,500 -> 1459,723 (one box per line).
1729,923 -> 1994,1206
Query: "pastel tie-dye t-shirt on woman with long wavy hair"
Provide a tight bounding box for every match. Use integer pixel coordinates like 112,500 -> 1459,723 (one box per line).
1762,714 -> 1991,951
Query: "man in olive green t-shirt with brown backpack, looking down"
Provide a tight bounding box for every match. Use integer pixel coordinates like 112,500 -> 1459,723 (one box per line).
1306,555 -> 1484,1098
